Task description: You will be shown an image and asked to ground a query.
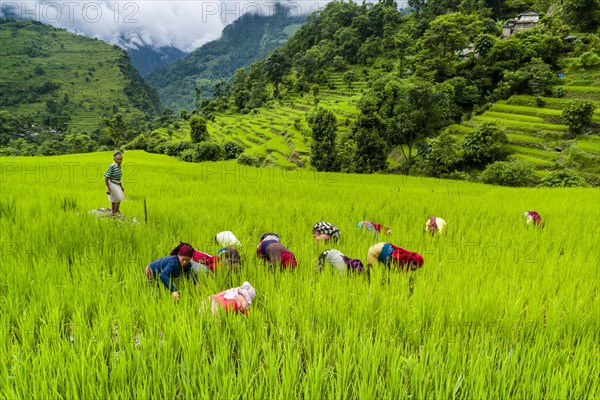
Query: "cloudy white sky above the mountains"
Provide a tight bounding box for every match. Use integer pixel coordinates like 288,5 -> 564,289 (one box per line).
0,0 -> 327,52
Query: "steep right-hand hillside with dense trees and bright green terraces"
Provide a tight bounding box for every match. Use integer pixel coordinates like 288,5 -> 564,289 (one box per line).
131,1 -> 600,186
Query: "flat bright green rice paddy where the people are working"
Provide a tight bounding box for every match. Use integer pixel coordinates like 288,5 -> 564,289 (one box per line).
0,151 -> 600,399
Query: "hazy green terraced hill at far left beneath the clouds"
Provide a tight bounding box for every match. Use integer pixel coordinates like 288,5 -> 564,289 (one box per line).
0,20 -> 160,147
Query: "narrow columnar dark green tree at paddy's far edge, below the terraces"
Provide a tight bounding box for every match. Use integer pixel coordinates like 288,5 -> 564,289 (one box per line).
309,108 -> 338,171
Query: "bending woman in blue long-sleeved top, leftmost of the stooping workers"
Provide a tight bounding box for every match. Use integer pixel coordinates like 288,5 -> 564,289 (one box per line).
146,243 -> 197,301
